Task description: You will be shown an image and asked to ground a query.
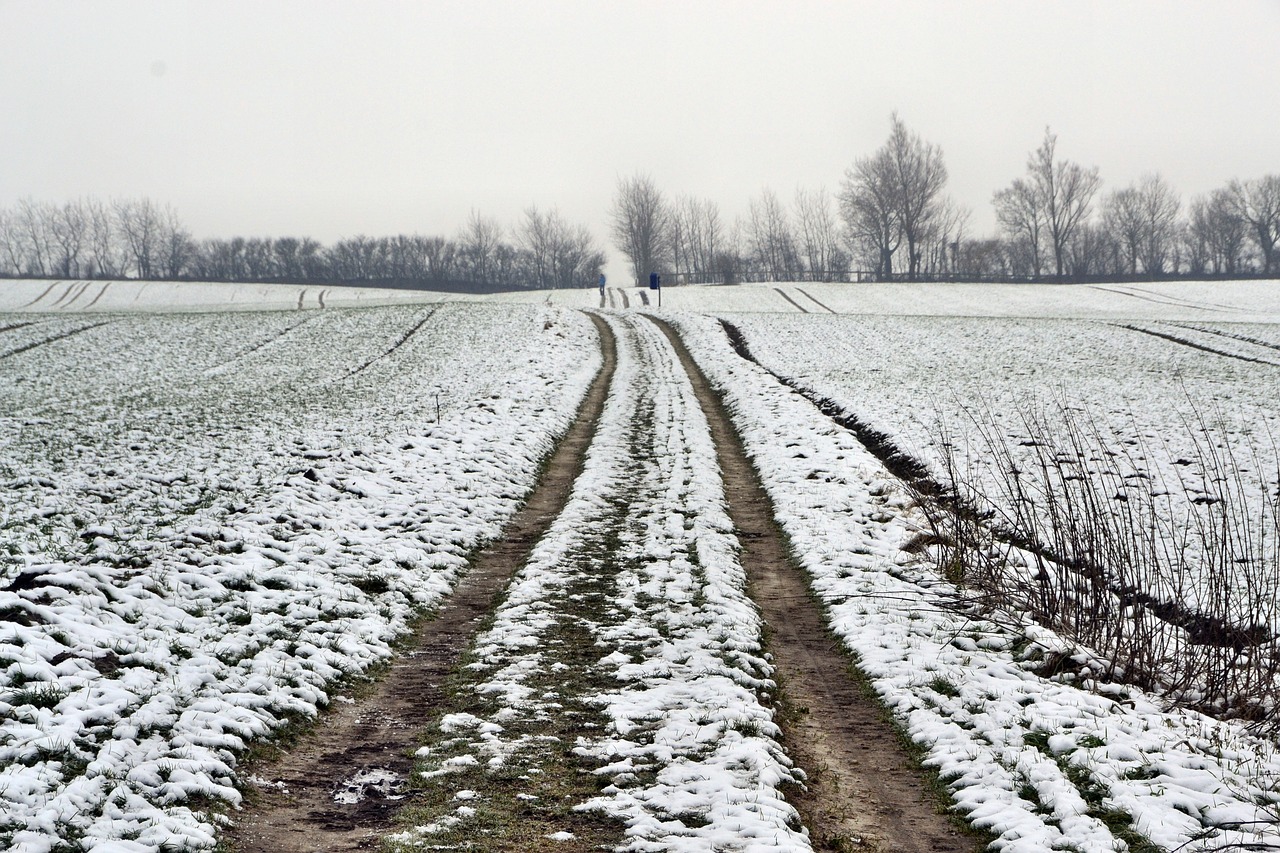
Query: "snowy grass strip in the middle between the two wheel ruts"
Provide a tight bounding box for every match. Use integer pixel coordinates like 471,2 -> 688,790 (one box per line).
393,316 -> 809,850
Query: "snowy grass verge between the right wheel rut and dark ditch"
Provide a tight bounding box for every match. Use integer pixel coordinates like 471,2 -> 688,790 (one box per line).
673,315 -> 1280,852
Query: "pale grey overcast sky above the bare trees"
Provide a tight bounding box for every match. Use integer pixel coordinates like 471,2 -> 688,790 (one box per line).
0,0 -> 1280,275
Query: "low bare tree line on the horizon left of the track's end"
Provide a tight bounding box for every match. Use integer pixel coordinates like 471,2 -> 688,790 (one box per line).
0,199 -> 605,289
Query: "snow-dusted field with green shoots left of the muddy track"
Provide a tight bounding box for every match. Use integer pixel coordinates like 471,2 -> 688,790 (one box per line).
0,305 -> 600,852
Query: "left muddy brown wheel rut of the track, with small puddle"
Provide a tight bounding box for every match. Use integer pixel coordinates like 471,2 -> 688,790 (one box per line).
228,315 -> 616,853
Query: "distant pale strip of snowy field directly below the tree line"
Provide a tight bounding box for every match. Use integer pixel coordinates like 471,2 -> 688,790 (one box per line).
17,279 -> 1280,323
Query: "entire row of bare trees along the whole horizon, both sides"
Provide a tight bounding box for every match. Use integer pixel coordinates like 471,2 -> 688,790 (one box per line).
0,113 -> 1280,289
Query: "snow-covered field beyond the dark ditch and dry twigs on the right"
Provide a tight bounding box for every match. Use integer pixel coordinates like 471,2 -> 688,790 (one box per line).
727,314 -> 1280,645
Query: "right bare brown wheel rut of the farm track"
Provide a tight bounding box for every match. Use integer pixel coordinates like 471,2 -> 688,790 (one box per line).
649,318 -> 977,853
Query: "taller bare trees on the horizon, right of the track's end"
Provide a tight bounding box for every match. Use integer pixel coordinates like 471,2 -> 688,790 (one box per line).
611,114 -> 1280,283
